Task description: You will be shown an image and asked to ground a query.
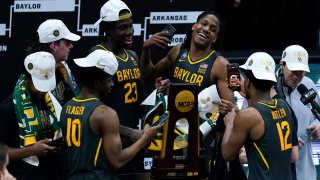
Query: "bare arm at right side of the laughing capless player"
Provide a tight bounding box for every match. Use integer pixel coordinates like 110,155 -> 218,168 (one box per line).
210,56 -> 234,105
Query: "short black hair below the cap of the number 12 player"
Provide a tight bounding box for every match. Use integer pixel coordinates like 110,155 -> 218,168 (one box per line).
244,70 -> 275,91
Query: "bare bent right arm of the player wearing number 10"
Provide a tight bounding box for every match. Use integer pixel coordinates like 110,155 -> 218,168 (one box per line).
94,105 -> 162,170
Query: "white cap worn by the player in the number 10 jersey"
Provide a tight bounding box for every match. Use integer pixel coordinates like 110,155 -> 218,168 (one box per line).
74,49 -> 118,76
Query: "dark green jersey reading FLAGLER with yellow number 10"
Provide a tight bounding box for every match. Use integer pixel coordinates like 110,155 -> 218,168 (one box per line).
60,98 -> 117,179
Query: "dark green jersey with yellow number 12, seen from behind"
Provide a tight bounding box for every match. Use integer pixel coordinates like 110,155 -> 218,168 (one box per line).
245,99 -> 297,180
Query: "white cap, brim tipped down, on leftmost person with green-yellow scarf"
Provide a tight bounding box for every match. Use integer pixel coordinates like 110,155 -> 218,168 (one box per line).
24,51 -> 56,92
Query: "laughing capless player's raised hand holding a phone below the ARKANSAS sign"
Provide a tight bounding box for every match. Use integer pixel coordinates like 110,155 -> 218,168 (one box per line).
143,31 -> 170,49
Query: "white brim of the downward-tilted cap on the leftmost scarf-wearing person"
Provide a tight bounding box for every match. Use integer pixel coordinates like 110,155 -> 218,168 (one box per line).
31,75 -> 56,92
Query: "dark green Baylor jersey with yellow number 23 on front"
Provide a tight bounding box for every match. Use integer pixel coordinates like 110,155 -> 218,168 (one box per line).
91,44 -> 143,131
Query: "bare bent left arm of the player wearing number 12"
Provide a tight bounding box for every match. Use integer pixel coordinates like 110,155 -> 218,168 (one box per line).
221,108 -> 264,161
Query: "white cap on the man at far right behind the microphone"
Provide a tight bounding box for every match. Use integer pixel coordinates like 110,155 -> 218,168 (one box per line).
282,45 -> 310,72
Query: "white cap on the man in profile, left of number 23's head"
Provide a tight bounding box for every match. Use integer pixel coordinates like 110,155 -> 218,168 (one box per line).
37,19 -> 80,43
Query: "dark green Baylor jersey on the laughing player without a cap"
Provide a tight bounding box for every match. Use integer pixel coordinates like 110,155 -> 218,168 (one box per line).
170,50 -> 220,92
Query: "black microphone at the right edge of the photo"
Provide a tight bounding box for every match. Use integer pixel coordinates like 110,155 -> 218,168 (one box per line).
297,84 -> 320,120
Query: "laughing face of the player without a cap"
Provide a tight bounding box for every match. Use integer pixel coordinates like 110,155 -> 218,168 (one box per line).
192,14 -> 220,48
